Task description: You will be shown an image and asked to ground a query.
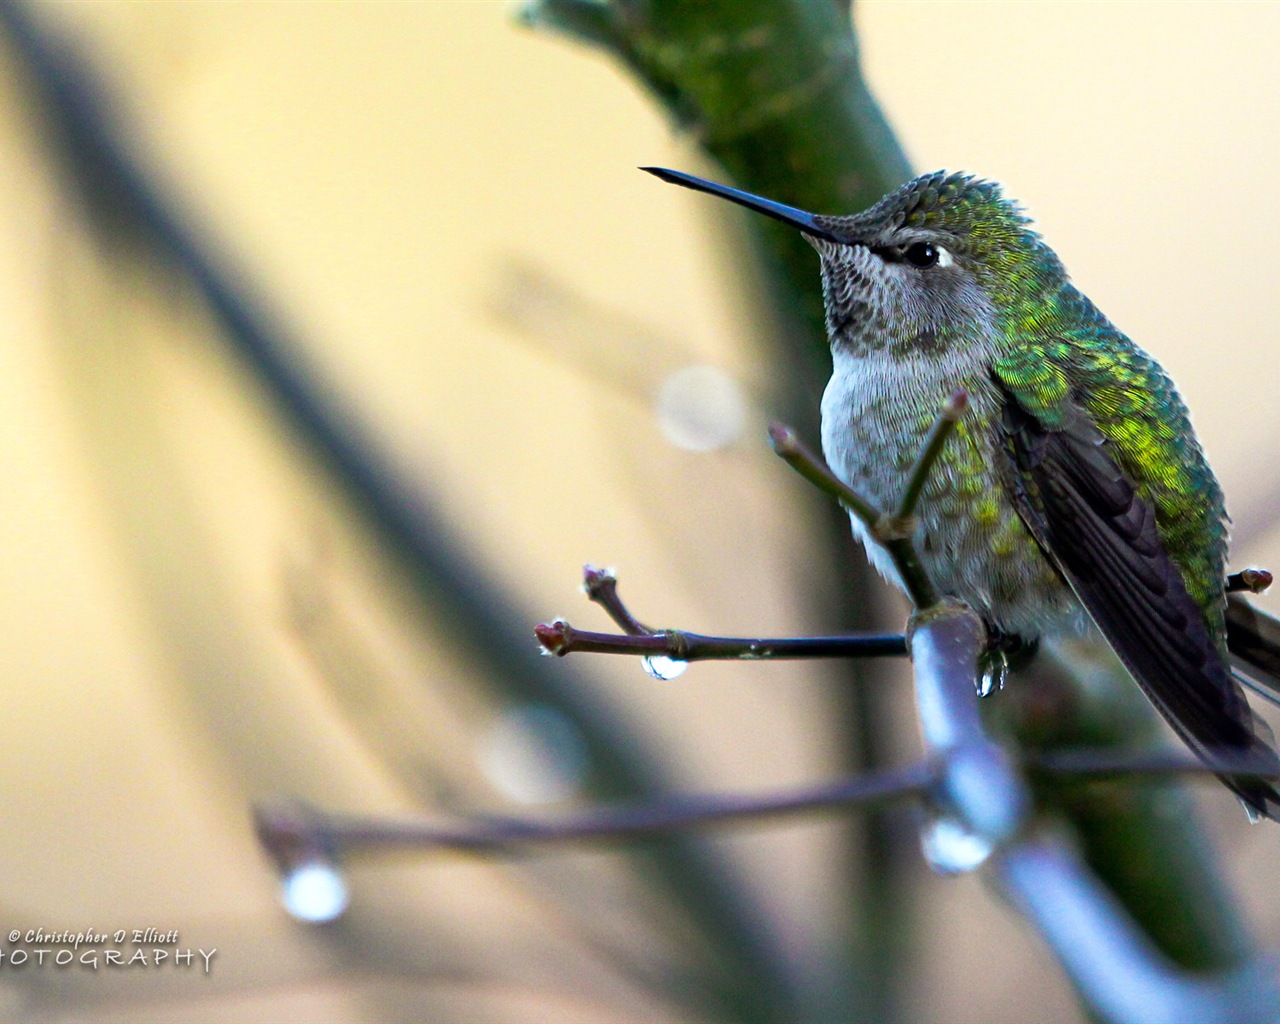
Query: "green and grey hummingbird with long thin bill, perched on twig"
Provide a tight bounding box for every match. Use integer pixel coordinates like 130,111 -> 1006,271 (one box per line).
643,168 -> 1280,820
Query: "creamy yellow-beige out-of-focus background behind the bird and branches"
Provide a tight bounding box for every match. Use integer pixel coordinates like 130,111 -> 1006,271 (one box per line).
0,0 -> 1280,1021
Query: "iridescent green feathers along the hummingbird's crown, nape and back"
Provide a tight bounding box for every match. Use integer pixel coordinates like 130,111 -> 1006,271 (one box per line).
844,172 -> 1226,644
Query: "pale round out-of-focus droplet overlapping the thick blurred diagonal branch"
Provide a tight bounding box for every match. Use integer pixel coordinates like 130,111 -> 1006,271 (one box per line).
479,704 -> 589,804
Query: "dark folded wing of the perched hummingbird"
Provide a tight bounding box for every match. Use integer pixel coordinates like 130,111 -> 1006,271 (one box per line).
995,364 -> 1280,817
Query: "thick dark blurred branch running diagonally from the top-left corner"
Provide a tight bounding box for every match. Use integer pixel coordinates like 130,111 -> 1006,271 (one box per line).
0,3 -> 787,1021
